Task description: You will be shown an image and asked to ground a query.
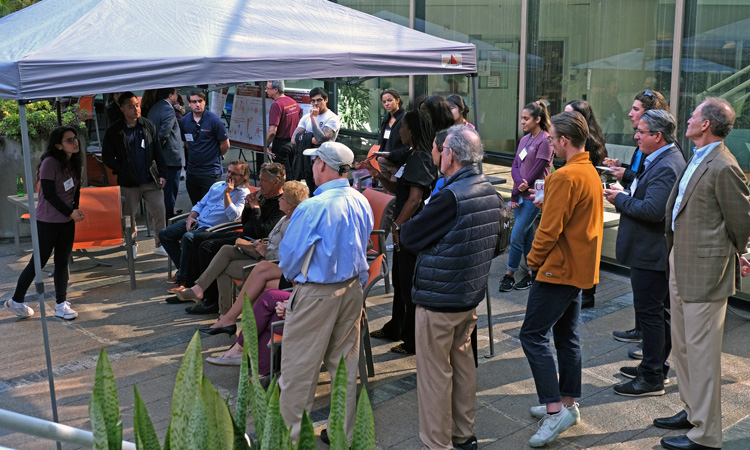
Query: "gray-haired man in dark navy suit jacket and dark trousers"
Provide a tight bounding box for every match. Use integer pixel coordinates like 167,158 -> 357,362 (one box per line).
604,109 -> 685,397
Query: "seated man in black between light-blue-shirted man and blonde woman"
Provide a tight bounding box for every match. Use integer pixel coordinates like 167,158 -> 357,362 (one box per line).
183,163 -> 286,314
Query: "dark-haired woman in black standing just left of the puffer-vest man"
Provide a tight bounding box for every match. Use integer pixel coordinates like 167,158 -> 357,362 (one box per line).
368,111 -> 437,354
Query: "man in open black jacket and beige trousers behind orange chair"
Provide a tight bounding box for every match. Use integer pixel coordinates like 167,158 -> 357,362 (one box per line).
102,92 -> 167,259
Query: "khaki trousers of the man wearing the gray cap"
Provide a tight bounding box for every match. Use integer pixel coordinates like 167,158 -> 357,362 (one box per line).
279,277 -> 362,443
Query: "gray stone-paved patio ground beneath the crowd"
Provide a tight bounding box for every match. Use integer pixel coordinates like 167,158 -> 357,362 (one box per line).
0,157 -> 750,450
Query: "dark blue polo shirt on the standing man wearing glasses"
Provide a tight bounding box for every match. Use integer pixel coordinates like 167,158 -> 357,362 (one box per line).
180,111 -> 227,175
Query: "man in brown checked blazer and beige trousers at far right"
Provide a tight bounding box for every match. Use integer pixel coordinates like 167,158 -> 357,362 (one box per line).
654,98 -> 750,450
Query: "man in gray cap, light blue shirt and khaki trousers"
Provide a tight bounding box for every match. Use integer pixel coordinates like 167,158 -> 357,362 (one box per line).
279,142 -> 373,443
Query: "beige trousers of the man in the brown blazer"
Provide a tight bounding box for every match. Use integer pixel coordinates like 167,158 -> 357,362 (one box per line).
669,251 -> 727,448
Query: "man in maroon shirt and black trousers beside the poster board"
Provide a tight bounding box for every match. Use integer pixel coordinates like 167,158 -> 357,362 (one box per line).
266,80 -> 302,180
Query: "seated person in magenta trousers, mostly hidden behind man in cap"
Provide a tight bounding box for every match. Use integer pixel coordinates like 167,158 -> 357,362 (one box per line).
206,289 -> 291,376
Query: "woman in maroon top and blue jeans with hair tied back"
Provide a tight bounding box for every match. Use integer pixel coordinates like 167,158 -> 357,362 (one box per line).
500,101 -> 553,292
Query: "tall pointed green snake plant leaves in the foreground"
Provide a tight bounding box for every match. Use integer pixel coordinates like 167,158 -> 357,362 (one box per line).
89,295 -> 375,450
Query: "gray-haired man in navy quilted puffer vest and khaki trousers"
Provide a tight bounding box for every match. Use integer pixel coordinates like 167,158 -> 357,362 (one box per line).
400,125 -> 500,450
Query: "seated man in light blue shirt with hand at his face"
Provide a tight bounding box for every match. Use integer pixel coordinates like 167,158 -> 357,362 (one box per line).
159,161 -> 250,292
